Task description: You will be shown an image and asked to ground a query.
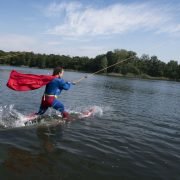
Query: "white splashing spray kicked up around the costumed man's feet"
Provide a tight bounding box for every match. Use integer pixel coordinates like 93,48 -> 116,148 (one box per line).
0,105 -> 103,129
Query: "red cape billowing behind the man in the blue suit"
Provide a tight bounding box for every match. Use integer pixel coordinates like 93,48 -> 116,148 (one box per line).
7,70 -> 55,91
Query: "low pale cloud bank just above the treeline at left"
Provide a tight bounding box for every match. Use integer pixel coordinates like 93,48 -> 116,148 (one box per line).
0,34 -> 102,57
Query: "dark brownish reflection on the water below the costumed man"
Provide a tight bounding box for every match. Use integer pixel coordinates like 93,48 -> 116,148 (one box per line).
3,126 -> 63,179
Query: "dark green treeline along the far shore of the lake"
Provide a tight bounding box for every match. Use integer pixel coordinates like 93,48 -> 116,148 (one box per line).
0,49 -> 180,80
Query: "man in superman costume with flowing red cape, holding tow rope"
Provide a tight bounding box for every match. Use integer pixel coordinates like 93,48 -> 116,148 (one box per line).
7,67 -> 74,119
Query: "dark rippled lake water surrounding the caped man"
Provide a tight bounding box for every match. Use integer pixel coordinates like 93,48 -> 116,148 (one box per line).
0,66 -> 180,180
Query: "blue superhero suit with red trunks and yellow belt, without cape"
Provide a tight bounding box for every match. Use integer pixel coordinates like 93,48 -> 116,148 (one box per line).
36,78 -> 71,118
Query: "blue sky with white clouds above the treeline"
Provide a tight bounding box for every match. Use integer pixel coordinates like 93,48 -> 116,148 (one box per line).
0,0 -> 180,63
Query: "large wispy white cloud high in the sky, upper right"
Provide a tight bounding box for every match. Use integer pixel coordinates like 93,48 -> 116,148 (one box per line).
44,2 -> 179,36
